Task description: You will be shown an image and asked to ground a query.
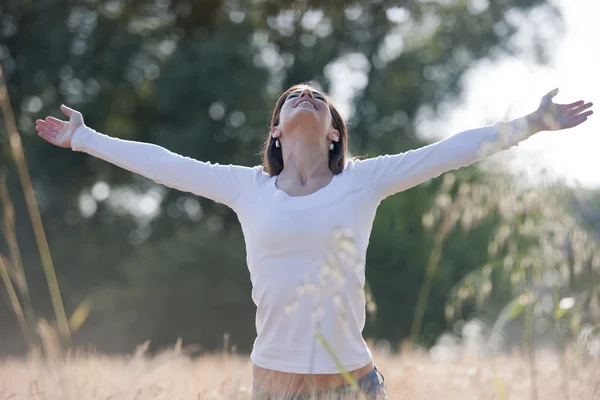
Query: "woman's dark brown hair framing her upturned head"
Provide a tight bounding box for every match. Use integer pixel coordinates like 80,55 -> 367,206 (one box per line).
262,84 -> 348,176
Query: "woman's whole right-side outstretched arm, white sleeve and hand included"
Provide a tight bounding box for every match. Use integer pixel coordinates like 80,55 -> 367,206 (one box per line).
353,89 -> 593,198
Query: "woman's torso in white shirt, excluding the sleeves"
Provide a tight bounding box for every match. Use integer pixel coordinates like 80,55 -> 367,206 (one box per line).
234,166 -> 380,380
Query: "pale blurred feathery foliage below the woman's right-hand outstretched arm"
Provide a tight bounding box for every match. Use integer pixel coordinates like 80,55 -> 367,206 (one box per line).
423,170 -> 600,348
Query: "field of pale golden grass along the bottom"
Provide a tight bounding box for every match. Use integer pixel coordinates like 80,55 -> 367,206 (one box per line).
0,350 -> 600,400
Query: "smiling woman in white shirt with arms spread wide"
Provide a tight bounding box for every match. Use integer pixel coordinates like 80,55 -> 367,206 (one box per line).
36,85 -> 592,399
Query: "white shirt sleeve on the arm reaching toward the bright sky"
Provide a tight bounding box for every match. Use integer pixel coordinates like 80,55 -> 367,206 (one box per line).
353,118 -> 530,199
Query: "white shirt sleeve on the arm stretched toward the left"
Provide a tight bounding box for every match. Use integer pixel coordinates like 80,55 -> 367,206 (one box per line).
71,125 -> 258,208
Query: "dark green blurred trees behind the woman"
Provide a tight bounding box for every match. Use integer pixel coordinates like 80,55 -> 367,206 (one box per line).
0,0 -> 559,351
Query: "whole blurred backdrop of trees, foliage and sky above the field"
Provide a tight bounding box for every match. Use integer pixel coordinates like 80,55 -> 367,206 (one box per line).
0,0 -> 600,357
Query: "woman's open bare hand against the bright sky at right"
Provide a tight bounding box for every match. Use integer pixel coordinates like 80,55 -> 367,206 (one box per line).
528,89 -> 594,133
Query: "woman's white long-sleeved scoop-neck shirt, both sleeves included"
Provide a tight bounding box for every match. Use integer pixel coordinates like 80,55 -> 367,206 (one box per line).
71,119 -> 529,374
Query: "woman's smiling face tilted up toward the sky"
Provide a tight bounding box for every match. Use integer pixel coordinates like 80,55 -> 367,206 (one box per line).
273,88 -> 339,141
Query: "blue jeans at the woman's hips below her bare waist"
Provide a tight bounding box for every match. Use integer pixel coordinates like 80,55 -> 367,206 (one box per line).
252,367 -> 387,400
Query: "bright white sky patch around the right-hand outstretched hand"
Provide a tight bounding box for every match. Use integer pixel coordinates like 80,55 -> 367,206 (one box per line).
422,0 -> 600,188
